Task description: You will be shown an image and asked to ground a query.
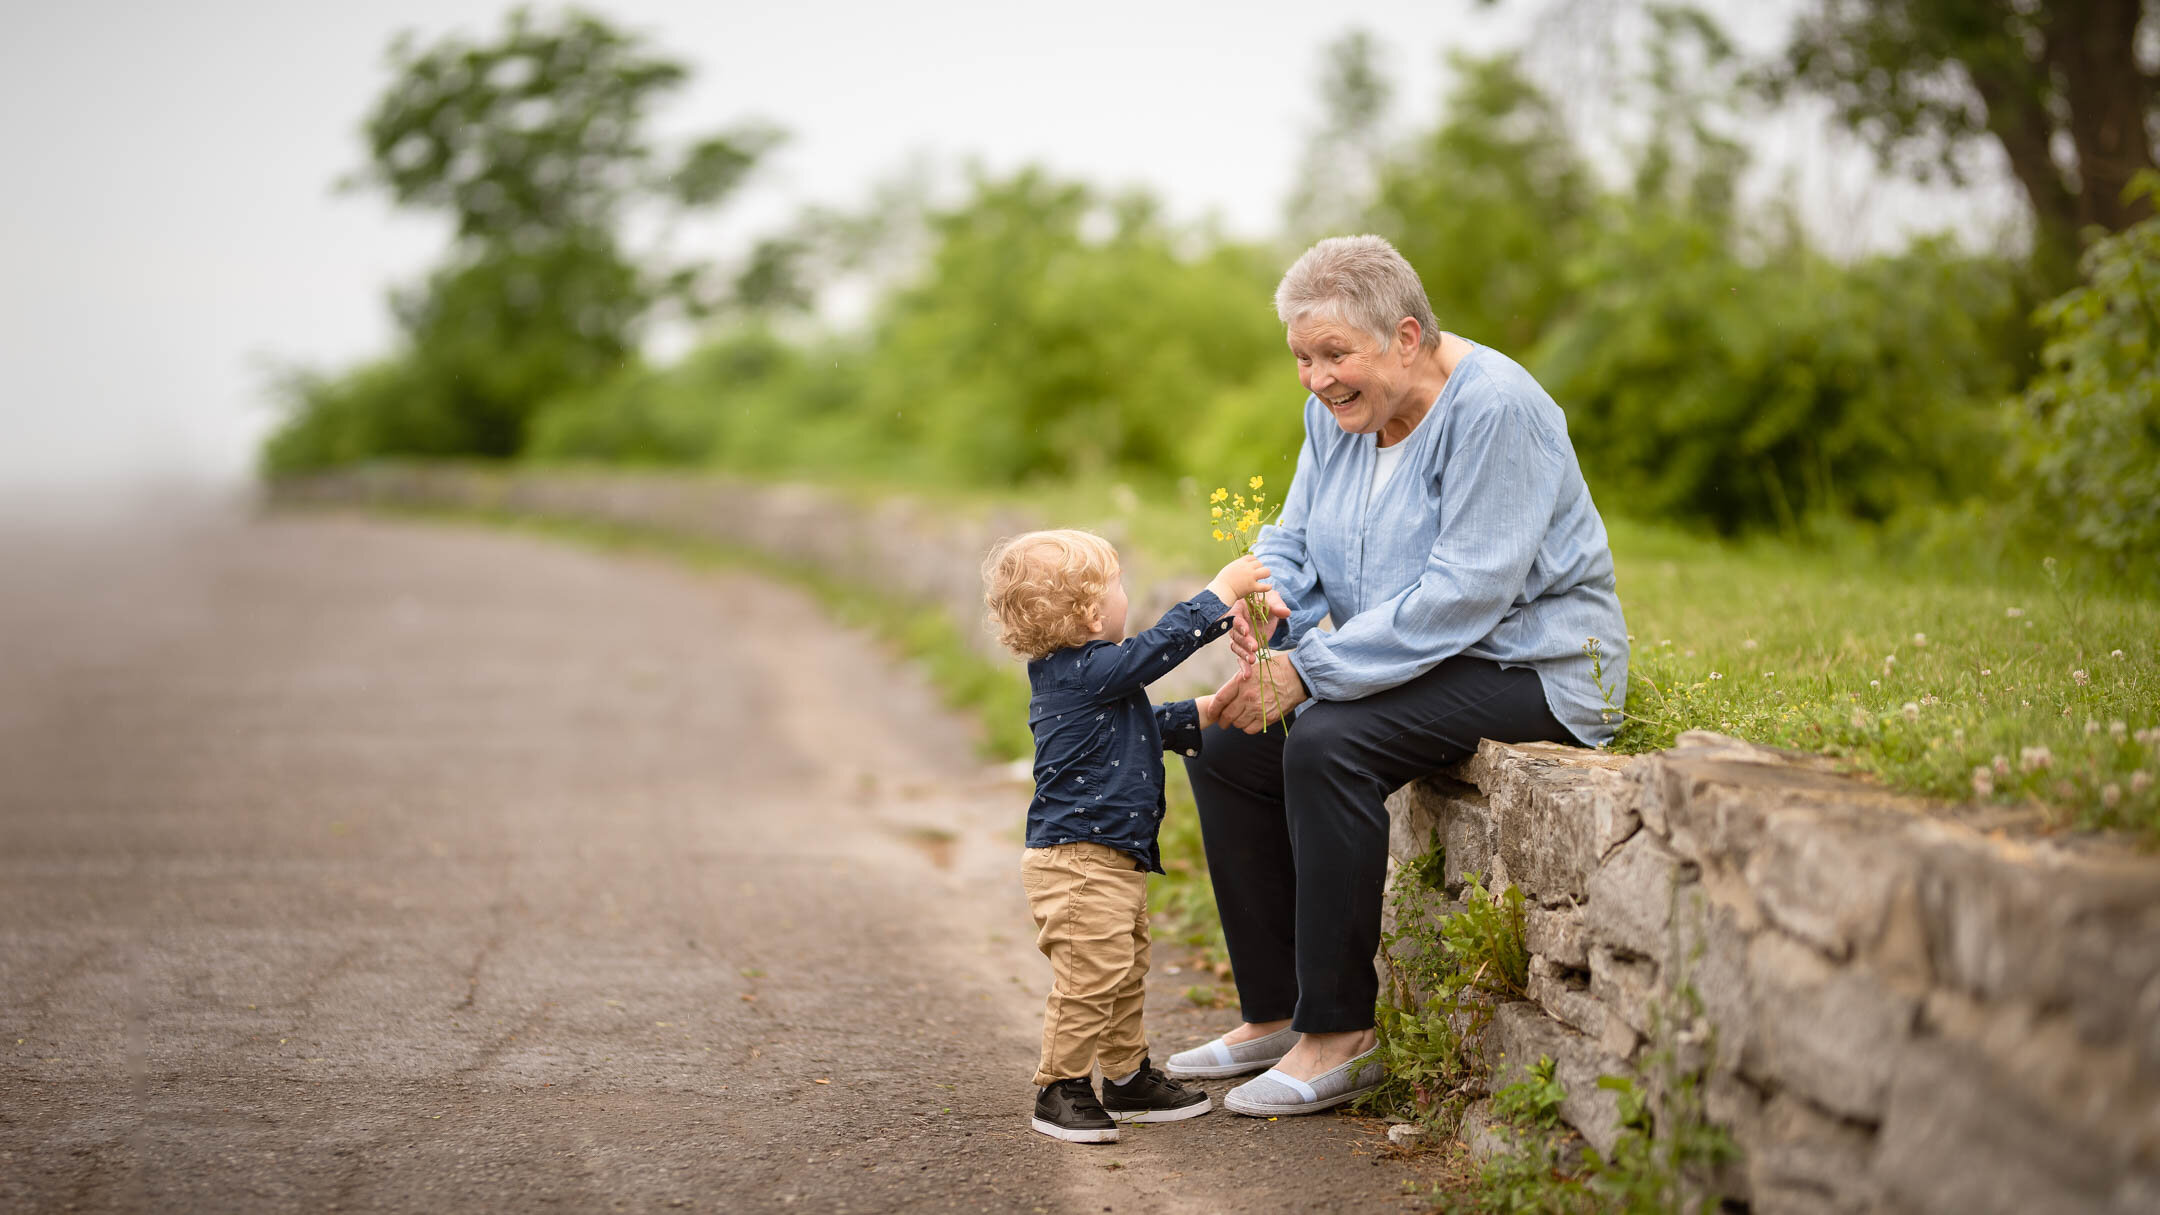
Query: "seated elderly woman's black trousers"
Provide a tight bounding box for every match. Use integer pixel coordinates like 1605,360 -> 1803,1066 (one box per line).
1186,657 -> 1577,1033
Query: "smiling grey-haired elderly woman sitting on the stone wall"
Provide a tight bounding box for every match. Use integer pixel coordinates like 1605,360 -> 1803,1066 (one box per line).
1169,236 -> 1626,1116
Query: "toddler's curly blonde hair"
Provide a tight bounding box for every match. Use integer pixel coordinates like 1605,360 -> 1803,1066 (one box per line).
983,528 -> 1119,659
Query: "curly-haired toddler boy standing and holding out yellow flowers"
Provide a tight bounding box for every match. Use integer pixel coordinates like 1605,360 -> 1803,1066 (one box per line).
983,530 -> 1268,1144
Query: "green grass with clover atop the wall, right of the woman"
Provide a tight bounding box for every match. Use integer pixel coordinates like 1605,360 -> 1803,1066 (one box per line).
1611,525 -> 2160,847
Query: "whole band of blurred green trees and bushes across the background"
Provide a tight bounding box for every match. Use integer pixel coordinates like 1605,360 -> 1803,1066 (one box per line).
264,9 -> 2160,588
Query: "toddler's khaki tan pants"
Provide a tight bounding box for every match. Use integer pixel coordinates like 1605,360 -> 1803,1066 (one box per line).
1020,843 -> 1147,1085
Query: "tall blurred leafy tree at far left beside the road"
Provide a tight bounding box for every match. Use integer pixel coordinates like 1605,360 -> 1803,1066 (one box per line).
266,9 -> 778,471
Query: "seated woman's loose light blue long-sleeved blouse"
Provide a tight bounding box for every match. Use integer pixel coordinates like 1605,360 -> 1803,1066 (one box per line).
1253,335 -> 1629,746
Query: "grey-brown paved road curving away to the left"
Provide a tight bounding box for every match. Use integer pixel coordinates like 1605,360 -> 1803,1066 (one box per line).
0,508 -> 1442,1213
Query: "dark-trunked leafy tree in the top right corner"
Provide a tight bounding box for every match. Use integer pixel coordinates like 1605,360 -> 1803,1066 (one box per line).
1767,0 -> 2160,266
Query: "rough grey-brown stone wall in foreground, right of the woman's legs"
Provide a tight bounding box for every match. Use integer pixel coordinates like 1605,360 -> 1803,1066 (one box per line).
1391,733 -> 2160,1215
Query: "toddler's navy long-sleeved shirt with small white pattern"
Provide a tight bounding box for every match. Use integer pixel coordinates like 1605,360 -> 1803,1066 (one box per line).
1028,590 -> 1231,873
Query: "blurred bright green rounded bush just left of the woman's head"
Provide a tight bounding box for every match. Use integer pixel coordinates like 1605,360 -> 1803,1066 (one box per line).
838,171 -> 1296,484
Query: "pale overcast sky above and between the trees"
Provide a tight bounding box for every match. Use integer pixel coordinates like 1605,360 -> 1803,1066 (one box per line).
0,0 -> 2004,491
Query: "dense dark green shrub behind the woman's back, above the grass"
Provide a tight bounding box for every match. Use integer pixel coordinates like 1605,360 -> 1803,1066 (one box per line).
1529,217 -> 2017,534
